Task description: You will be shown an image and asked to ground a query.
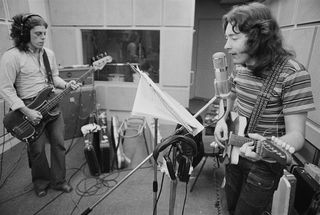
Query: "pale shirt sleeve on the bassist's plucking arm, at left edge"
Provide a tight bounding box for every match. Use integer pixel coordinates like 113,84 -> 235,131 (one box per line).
0,53 -> 25,110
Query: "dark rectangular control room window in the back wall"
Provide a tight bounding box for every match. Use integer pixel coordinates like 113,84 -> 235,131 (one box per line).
82,29 -> 160,83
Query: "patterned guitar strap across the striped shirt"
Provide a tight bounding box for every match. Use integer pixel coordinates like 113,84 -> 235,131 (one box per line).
247,57 -> 287,133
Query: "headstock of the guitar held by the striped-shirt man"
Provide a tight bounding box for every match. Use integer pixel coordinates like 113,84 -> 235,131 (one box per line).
256,137 -> 295,166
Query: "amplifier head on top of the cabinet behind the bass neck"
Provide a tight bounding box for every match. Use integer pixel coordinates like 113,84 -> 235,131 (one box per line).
59,67 -> 94,85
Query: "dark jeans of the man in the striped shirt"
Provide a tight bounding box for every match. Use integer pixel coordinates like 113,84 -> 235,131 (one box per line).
225,157 -> 283,215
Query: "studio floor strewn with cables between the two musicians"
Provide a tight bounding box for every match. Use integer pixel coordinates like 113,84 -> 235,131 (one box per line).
0,98 -> 227,215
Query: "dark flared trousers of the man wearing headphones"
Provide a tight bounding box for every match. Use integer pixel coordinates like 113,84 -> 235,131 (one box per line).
28,111 -> 66,189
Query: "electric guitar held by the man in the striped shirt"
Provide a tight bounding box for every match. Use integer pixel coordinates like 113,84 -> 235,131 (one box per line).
224,113 -> 295,166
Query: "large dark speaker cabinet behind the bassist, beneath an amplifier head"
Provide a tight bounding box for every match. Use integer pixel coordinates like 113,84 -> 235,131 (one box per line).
60,85 -> 96,140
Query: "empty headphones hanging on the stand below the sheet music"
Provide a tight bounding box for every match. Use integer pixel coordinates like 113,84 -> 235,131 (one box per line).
153,135 -> 197,182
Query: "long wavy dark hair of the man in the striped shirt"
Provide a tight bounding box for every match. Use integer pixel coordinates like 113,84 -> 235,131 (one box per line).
223,2 -> 293,76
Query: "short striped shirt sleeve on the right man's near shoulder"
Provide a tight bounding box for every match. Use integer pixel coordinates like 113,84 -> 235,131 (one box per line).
282,69 -> 315,114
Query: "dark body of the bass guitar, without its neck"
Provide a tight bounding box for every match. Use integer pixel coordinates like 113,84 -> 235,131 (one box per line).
3,87 -> 60,143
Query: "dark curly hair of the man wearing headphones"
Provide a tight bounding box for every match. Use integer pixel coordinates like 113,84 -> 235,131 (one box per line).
10,13 -> 48,52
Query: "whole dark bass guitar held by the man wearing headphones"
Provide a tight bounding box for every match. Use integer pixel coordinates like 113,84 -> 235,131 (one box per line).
3,56 -> 112,144
